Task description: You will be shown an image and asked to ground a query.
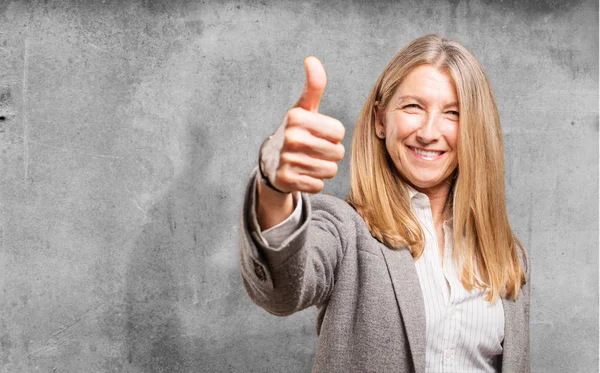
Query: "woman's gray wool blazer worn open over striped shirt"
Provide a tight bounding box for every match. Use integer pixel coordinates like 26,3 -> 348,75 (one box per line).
240,170 -> 530,373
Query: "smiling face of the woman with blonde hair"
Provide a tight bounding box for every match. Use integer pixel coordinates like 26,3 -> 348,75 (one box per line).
376,65 -> 459,192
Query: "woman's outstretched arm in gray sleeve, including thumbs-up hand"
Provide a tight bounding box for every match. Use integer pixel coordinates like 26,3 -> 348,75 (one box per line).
240,57 -> 351,315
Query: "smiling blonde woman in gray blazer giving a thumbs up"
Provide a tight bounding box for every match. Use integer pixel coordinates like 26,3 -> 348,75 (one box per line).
240,35 -> 530,372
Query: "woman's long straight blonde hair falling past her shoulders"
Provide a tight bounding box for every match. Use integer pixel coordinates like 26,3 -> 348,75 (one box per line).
347,35 -> 526,302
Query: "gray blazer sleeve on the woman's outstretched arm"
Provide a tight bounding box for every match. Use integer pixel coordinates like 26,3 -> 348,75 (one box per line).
239,169 -> 356,316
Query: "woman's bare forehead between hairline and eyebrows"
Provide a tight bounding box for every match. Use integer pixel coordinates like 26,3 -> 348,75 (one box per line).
393,65 -> 458,102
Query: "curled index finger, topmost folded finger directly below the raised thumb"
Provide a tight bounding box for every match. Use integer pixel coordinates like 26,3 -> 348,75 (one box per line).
287,108 -> 346,144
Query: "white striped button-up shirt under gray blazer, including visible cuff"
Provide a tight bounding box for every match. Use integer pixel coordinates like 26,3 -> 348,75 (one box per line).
262,184 -> 504,373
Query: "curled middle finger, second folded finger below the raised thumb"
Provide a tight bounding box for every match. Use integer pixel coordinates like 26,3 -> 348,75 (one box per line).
281,127 -> 345,162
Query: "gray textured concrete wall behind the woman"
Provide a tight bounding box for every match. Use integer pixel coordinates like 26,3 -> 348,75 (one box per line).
0,0 -> 599,373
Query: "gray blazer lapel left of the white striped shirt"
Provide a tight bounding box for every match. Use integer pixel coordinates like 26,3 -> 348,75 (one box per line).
381,245 -> 427,372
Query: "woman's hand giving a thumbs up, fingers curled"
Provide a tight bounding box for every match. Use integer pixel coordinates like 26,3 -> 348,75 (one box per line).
260,57 -> 345,193
